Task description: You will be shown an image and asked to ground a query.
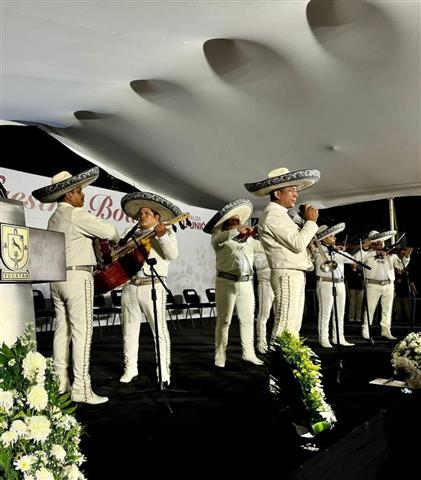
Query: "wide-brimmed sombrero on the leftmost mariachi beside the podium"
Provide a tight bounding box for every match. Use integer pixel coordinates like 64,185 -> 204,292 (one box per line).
32,167 -> 99,203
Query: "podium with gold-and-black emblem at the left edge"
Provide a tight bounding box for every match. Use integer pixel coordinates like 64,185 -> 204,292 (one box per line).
0,198 -> 66,345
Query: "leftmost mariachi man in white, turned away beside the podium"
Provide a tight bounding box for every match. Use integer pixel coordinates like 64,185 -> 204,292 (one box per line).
32,167 -> 119,405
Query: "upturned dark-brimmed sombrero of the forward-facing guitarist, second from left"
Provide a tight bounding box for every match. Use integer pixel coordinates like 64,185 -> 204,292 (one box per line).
121,192 -> 182,222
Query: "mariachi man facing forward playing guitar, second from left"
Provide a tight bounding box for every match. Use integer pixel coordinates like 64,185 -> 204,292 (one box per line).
120,192 -> 181,388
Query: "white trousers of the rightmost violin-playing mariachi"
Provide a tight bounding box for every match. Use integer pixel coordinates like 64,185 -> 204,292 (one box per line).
362,283 -> 395,335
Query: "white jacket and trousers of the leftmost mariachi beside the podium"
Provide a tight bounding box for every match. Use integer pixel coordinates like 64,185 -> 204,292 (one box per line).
48,202 -> 119,401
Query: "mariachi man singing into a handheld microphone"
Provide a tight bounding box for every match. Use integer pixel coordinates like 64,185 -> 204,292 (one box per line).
244,167 -> 320,340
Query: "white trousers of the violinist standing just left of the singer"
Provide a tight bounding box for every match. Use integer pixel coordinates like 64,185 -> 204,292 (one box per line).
215,277 -> 255,356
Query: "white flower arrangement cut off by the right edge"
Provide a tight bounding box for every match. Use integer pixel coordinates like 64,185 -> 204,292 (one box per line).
392,332 -> 421,388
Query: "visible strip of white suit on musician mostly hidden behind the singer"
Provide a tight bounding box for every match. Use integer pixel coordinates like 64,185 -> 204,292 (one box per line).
254,248 -> 274,353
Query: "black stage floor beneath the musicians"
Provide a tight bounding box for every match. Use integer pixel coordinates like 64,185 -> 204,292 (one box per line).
37,319 -> 421,480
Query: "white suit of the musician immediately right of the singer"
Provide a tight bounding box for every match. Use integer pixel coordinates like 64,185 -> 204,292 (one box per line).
314,245 -> 354,346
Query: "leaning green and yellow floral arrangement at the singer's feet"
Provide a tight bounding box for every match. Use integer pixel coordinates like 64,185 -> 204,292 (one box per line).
269,330 -> 336,434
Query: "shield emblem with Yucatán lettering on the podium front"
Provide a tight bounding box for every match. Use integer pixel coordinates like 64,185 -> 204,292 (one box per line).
1,223 -> 31,280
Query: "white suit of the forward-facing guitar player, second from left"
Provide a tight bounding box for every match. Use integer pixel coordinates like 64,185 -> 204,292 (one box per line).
121,228 -> 178,384
